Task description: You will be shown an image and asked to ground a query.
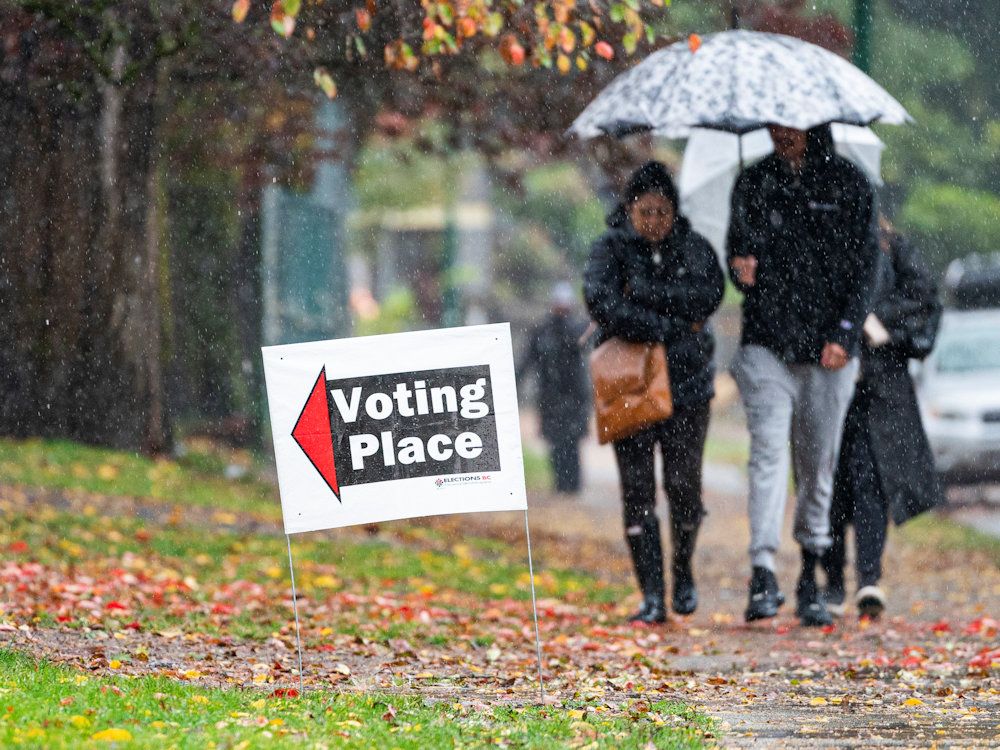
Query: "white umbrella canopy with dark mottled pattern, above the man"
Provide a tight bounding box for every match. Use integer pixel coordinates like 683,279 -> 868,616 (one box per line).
570,30 -> 911,138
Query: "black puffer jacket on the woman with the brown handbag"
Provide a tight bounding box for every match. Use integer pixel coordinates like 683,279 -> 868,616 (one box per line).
583,210 -> 724,407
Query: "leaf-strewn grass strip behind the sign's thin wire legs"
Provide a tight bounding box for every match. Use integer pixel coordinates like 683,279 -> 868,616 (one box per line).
0,496 -> 626,638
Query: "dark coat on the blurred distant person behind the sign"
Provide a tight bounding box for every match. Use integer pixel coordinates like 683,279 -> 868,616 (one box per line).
517,313 -> 590,443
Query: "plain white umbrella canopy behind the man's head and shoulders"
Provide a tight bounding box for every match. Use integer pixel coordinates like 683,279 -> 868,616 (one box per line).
677,123 -> 885,255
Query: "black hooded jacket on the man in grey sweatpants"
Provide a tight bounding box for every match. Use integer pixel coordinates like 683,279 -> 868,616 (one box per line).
727,128 -> 878,363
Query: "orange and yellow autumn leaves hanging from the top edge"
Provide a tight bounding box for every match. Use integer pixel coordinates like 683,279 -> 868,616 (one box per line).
232,0 -> 664,98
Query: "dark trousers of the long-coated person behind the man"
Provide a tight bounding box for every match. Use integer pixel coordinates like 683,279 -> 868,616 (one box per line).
823,420 -> 889,588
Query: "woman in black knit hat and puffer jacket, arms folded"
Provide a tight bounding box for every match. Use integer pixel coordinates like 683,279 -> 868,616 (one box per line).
584,162 -> 723,623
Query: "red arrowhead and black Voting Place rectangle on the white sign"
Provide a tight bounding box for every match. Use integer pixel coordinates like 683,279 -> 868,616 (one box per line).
292,365 -> 500,500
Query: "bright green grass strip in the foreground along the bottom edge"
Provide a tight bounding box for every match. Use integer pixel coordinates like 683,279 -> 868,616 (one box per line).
0,650 -> 712,750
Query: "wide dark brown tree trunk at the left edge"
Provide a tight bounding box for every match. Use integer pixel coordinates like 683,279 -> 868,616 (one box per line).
0,39 -> 167,452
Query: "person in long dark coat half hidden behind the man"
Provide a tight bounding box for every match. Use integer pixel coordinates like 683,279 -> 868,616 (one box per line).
823,225 -> 943,617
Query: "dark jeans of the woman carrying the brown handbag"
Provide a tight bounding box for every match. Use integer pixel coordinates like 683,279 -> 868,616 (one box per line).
614,401 -> 708,534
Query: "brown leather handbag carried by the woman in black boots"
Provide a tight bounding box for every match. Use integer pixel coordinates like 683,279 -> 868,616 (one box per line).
590,336 -> 674,445
